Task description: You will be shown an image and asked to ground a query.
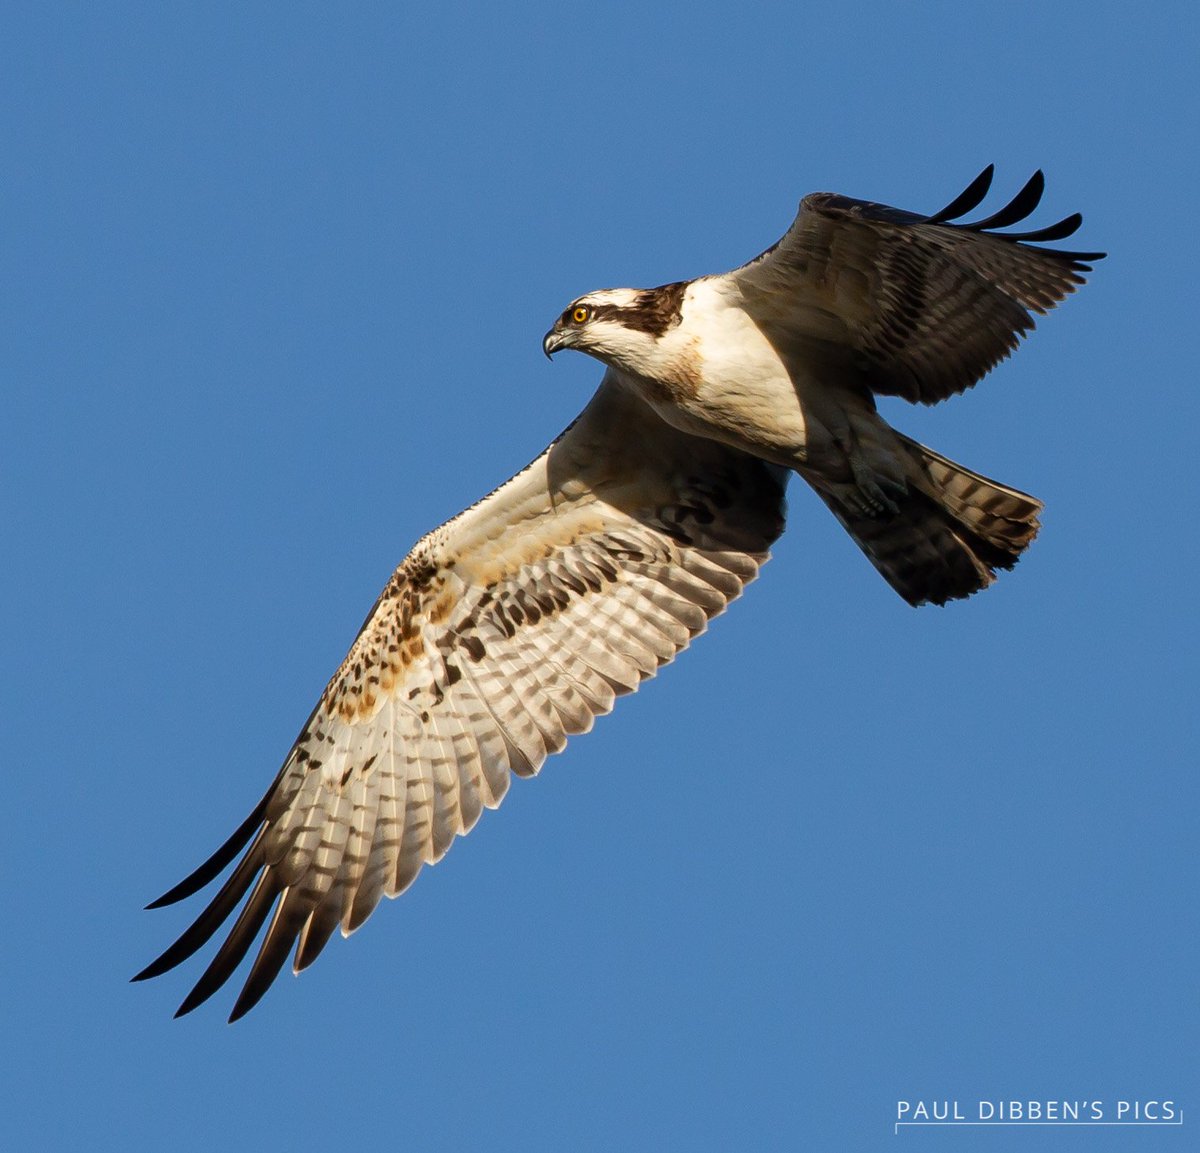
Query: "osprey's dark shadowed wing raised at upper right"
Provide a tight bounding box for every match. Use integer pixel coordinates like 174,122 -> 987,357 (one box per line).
726,164 -> 1104,404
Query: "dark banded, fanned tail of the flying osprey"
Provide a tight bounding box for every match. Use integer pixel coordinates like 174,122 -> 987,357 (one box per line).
817,433 -> 1042,605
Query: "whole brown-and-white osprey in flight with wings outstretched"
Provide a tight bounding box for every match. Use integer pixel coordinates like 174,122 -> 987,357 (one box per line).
134,166 -> 1104,1020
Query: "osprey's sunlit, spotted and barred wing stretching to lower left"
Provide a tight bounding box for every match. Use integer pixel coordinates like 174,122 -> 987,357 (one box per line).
134,372 -> 786,1020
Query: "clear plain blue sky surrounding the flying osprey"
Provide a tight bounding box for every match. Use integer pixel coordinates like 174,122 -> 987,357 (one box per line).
0,2 -> 1200,1151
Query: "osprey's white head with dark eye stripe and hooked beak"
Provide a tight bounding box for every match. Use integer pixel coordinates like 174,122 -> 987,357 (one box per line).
541,282 -> 688,373
